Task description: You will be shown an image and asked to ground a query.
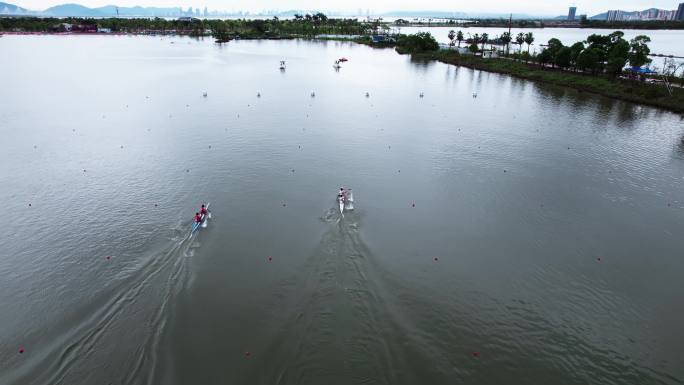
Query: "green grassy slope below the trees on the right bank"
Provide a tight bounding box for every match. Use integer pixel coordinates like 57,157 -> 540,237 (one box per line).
397,49 -> 684,114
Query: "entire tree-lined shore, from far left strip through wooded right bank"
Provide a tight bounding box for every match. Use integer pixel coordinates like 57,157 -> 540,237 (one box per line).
0,13 -> 684,113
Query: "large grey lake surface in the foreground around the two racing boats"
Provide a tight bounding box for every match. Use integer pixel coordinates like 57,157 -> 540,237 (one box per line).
0,36 -> 684,385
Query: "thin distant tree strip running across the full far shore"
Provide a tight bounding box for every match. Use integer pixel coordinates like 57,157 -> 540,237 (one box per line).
0,12 -> 684,37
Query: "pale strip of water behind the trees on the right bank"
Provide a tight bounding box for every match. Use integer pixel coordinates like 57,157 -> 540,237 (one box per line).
393,27 -> 684,57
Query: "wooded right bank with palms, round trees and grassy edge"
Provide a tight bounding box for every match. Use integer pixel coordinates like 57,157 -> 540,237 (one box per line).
382,31 -> 684,113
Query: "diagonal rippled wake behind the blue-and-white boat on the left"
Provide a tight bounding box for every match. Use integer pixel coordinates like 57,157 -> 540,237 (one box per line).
9,225 -> 194,384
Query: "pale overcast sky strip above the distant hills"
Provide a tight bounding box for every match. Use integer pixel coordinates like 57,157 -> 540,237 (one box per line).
10,0 -> 684,15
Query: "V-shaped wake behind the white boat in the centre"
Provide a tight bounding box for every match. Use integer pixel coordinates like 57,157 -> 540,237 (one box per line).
252,210 -> 430,384
